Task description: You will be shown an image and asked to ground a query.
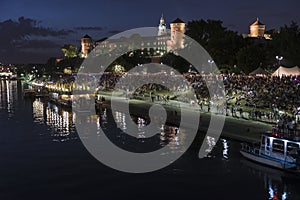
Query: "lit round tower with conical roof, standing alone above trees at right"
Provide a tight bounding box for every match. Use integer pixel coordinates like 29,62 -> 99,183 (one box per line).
243,18 -> 272,40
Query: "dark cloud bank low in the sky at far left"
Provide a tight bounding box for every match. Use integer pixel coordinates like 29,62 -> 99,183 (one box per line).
0,17 -> 74,63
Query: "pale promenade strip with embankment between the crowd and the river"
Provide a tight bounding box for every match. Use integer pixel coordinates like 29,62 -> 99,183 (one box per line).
102,95 -> 275,142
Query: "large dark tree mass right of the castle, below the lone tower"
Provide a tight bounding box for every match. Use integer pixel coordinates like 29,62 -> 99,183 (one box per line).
186,20 -> 300,74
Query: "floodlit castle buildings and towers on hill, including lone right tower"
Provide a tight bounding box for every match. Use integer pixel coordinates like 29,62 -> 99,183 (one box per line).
81,15 -> 272,58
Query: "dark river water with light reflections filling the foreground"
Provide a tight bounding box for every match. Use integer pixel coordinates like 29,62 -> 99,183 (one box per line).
0,80 -> 300,200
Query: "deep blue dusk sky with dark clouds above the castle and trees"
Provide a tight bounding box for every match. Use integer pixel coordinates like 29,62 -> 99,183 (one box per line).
0,0 -> 300,64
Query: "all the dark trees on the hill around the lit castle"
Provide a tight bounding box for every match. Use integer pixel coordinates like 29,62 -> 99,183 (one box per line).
37,19 -> 300,74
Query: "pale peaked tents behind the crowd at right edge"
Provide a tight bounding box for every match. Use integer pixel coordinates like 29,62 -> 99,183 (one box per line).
249,66 -> 300,76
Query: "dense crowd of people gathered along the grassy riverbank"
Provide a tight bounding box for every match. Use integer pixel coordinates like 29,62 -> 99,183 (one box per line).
94,72 -> 300,124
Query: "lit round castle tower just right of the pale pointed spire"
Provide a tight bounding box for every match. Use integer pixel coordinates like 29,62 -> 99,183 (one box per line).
168,18 -> 185,50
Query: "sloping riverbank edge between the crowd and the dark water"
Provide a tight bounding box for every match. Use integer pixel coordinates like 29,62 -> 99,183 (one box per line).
99,95 -> 274,142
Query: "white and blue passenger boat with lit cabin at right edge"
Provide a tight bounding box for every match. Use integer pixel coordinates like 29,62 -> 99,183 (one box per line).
240,129 -> 300,170
